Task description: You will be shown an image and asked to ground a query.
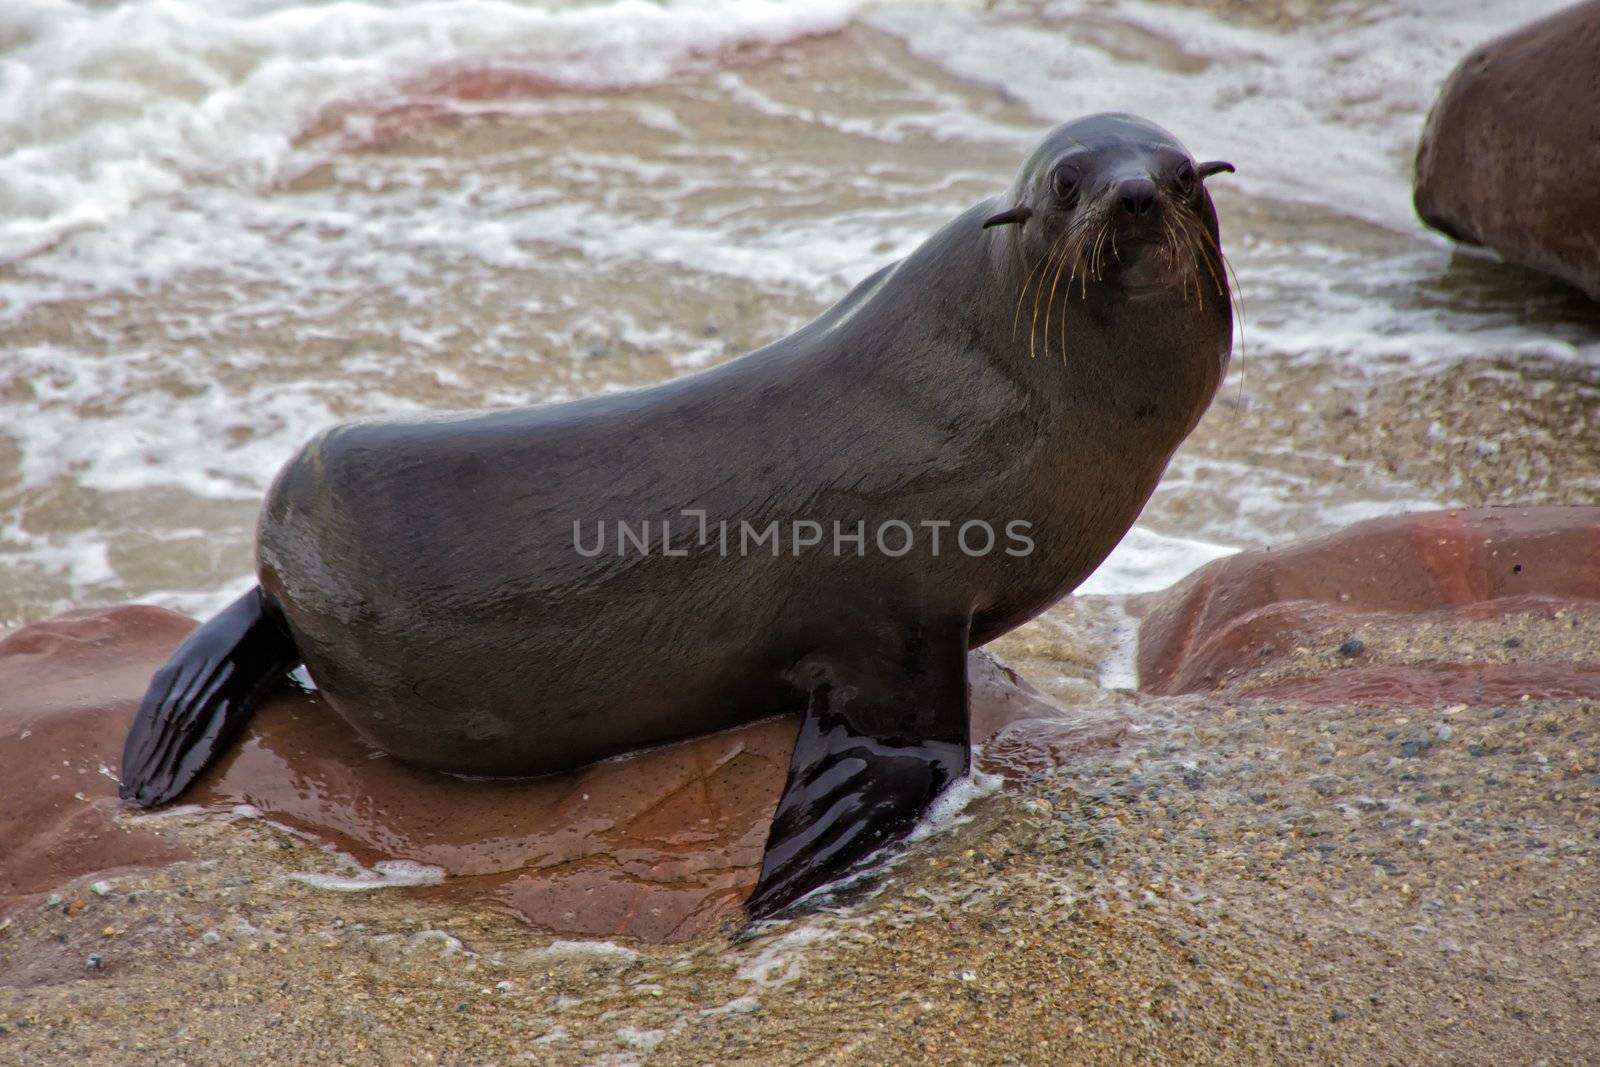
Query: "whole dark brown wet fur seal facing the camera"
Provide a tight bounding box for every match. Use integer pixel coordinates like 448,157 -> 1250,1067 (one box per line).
122,115 -> 1234,918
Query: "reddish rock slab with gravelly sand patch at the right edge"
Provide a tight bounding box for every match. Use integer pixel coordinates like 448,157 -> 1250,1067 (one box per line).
1134,507 -> 1600,705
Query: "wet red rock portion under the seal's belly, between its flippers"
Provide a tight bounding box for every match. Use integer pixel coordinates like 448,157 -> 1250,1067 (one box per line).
198,694 -> 795,941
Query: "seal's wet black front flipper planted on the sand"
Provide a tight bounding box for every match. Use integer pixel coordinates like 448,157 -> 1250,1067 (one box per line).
746,625 -> 970,920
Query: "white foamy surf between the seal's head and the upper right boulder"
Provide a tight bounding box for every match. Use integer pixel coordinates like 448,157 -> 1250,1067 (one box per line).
866,0 -> 1565,232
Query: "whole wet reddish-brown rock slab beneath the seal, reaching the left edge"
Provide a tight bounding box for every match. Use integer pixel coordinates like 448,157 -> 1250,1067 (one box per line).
0,606 -> 1118,941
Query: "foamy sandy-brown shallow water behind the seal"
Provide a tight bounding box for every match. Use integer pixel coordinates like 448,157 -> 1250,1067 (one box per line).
0,0 -> 1600,622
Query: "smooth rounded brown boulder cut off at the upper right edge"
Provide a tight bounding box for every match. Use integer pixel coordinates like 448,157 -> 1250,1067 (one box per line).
1416,0 -> 1600,299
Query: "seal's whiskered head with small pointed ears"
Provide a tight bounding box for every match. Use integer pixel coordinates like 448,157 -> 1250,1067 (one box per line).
984,114 -> 1234,298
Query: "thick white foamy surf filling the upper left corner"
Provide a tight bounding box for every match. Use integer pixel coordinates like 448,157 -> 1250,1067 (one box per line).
0,0 -> 858,261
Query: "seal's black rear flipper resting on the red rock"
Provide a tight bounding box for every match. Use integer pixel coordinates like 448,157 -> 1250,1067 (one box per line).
118,585 -> 301,808
